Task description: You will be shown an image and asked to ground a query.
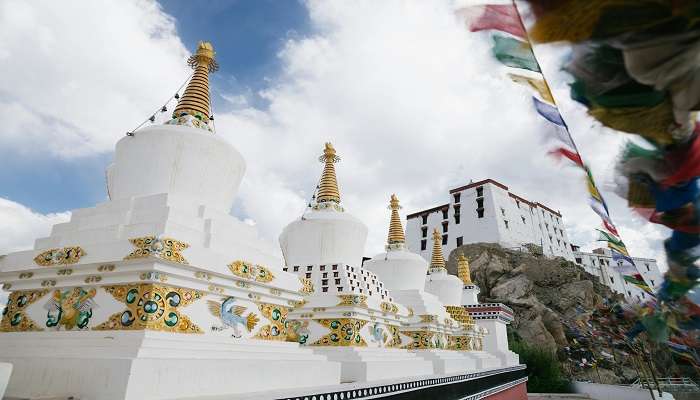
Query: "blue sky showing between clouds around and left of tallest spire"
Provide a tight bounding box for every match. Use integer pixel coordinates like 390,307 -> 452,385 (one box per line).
0,0 -> 309,213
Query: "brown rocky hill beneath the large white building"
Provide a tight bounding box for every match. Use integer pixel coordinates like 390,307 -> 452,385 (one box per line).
447,243 -> 635,383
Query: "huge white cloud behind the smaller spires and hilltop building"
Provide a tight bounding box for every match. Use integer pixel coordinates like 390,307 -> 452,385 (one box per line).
217,1 -> 662,268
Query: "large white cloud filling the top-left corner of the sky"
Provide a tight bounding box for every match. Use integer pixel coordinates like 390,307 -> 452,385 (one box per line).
0,0 -> 189,157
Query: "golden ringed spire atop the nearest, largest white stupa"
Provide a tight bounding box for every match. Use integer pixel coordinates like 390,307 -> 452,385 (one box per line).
173,42 -> 219,124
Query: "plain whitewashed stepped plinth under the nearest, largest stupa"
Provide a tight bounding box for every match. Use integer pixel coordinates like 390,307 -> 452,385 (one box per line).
0,331 -> 340,400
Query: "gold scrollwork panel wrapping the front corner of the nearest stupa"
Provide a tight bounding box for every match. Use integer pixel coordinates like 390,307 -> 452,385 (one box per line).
92,283 -> 204,333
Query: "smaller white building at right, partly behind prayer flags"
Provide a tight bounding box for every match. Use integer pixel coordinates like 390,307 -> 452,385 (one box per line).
574,247 -> 663,302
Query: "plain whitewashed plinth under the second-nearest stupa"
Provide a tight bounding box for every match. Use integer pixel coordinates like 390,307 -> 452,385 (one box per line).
314,347 -> 434,382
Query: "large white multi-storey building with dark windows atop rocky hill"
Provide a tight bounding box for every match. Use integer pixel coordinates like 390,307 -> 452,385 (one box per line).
406,179 -> 574,261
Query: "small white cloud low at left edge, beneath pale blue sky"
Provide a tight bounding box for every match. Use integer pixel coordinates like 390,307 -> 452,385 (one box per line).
0,197 -> 70,254
